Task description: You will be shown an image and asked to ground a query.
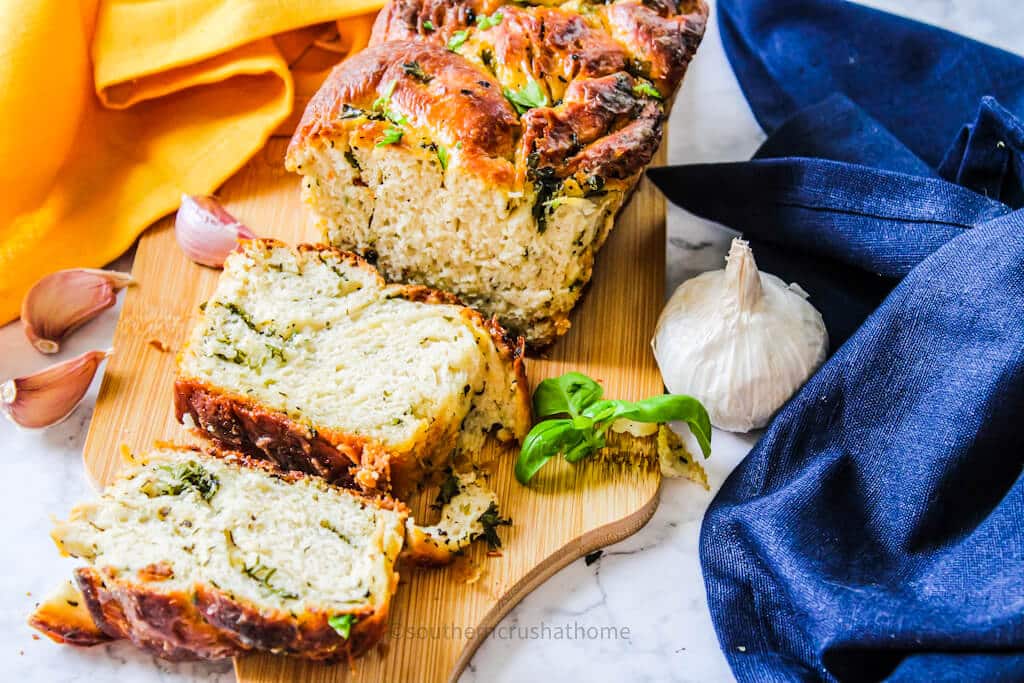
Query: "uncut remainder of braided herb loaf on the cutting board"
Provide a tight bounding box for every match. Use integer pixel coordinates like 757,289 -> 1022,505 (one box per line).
286,0 -> 708,345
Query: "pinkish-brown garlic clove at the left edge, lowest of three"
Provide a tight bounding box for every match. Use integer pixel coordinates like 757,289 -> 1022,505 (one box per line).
0,350 -> 113,429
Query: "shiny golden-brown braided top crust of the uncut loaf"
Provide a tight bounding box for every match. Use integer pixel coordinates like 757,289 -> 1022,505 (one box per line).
288,0 -> 708,189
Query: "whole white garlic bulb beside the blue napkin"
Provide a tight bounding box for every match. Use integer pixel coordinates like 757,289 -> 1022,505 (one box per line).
651,239 -> 828,432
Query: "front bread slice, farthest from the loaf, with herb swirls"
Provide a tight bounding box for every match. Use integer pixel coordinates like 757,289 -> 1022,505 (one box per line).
32,446 -> 408,659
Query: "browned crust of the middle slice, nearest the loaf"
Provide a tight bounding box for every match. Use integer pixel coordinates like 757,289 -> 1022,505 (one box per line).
174,239 -> 530,498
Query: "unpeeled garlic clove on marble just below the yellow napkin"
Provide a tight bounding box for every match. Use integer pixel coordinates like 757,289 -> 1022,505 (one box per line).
22,268 -> 134,353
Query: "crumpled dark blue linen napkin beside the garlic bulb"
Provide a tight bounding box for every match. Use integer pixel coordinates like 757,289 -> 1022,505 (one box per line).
650,0 -> 1024,681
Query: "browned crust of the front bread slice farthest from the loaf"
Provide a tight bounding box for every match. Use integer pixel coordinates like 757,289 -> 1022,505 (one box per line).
39,446 -> 409,660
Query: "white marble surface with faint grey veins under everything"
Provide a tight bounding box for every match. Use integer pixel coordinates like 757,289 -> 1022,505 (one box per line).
0,0 -> 1024,683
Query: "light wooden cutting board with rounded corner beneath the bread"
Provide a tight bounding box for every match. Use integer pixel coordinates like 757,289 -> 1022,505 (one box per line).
85,138 -> 665,683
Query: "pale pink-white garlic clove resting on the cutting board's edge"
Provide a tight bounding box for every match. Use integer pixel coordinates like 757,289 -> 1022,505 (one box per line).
174,195 -> 256,268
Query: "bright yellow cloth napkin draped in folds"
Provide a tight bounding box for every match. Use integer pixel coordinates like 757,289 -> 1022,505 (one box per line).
0,0 -> 383,324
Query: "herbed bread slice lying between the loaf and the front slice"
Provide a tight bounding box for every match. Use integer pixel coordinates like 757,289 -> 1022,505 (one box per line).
175,240 -> 530,494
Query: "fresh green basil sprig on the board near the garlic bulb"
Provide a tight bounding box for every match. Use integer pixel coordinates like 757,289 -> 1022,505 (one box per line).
515,373 -> 711,484
